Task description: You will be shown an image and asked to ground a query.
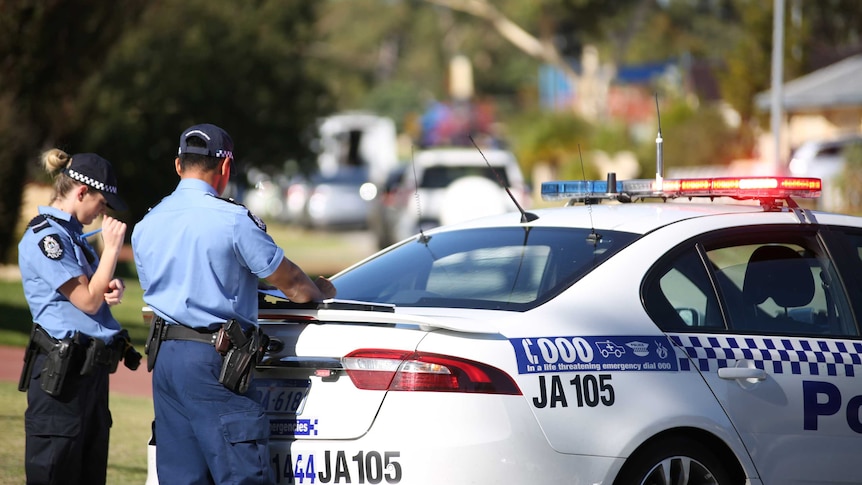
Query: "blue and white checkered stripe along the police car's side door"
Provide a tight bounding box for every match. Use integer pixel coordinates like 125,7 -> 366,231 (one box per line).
668,334 -> 862,377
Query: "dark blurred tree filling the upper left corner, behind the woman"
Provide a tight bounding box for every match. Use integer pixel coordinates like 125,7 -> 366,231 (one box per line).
0,0 -> 145,261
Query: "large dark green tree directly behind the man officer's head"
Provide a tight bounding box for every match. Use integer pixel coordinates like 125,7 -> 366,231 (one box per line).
71,0 -> 331,220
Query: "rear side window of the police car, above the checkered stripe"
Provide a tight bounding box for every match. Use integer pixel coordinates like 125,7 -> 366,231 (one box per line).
644,233 -> 858,336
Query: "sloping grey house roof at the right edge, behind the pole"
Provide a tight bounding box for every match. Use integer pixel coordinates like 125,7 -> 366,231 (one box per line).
755,54 -> 862,111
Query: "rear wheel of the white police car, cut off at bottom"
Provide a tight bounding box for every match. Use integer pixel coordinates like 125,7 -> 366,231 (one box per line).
614,436 -> 731,485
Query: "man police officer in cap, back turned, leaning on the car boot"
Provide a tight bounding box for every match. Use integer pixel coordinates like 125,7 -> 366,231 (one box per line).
132,124 -> 335,484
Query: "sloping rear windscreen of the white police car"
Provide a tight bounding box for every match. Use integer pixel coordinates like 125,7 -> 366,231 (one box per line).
333,227 -> 637,311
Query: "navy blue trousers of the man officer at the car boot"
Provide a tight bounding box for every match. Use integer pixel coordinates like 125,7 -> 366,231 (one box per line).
153,340 -> 275,485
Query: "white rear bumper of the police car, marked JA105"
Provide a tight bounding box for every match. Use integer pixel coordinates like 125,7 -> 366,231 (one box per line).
270,392 -> 623,484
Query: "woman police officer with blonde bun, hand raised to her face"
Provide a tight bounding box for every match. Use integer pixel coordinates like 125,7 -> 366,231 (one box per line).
18,149 -> 141,485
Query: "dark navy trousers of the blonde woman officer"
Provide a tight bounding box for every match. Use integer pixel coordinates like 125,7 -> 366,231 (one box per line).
24,354 -> 112,485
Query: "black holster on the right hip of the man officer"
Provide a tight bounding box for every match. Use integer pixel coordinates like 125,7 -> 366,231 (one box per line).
217,319 -> 269,394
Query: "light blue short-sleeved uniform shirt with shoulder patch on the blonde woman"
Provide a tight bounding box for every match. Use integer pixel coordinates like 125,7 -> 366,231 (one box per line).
18,207 -> 120,343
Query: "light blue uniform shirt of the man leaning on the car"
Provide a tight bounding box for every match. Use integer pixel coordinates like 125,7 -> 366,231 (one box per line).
132,179 -> 284,330
